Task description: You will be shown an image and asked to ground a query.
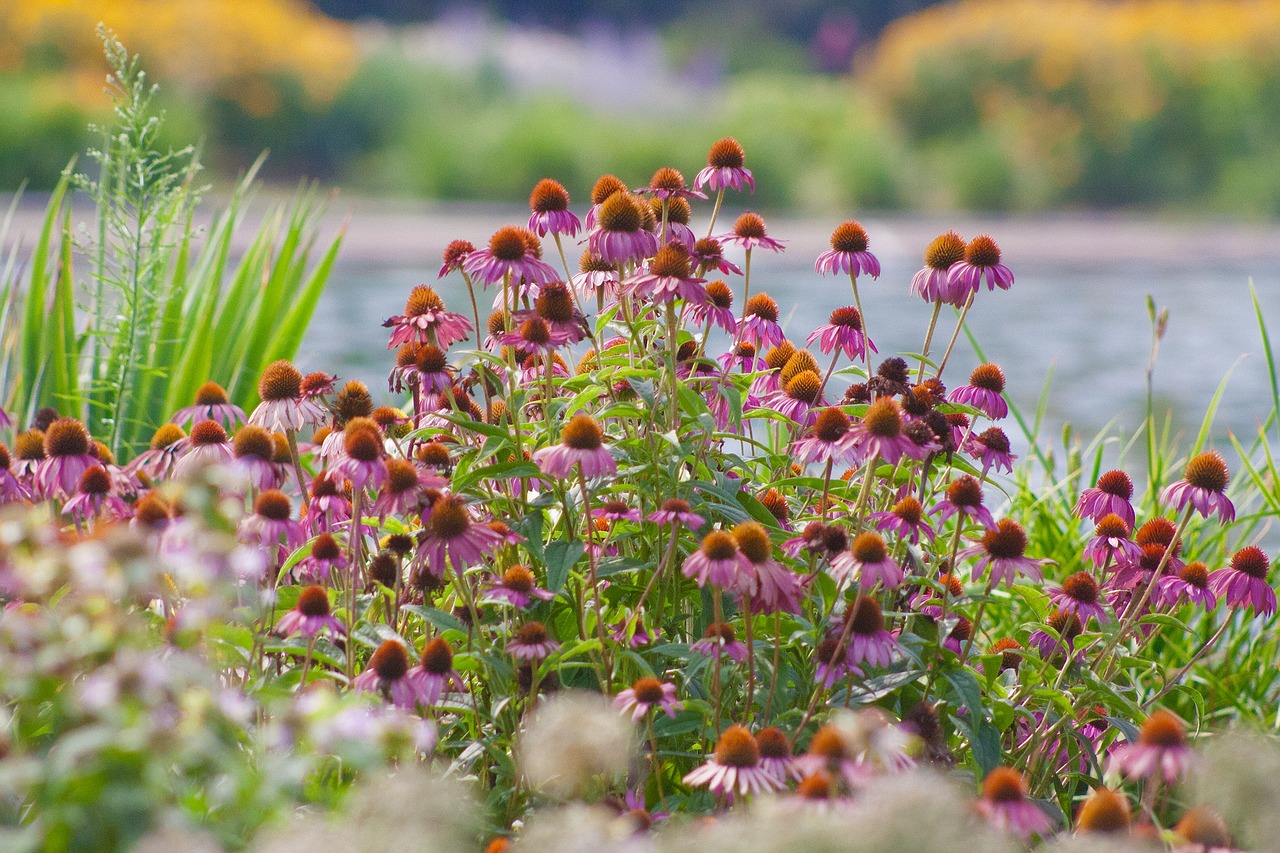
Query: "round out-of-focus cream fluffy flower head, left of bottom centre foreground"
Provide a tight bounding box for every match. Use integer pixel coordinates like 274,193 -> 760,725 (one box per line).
517,692 -> 635,799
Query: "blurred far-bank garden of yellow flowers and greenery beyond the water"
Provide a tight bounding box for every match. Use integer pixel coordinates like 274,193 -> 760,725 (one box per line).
0,0 -> 1280,213
